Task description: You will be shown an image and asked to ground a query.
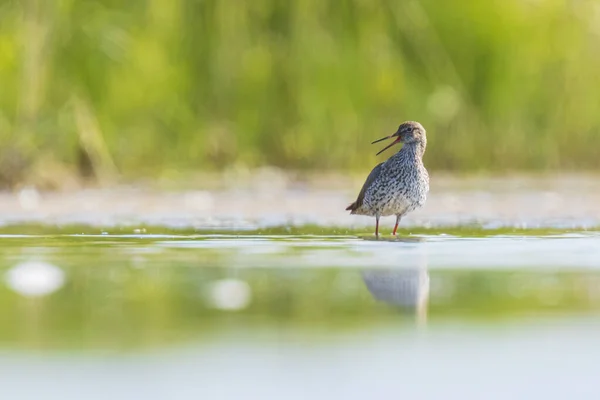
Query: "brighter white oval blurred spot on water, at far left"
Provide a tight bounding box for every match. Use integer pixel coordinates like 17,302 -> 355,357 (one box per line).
4,261 -> 65,297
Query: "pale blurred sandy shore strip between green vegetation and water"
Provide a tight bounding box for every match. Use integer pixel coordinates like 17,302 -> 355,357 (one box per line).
0,170 -> 600,229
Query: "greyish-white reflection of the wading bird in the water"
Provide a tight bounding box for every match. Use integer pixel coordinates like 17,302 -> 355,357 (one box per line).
362,256 -> 429,326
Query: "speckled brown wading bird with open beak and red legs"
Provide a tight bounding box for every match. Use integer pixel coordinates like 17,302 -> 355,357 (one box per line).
346,121 -> 429,238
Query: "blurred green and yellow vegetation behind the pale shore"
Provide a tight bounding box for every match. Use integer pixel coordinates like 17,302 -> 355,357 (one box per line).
0,0 -> 600,184
